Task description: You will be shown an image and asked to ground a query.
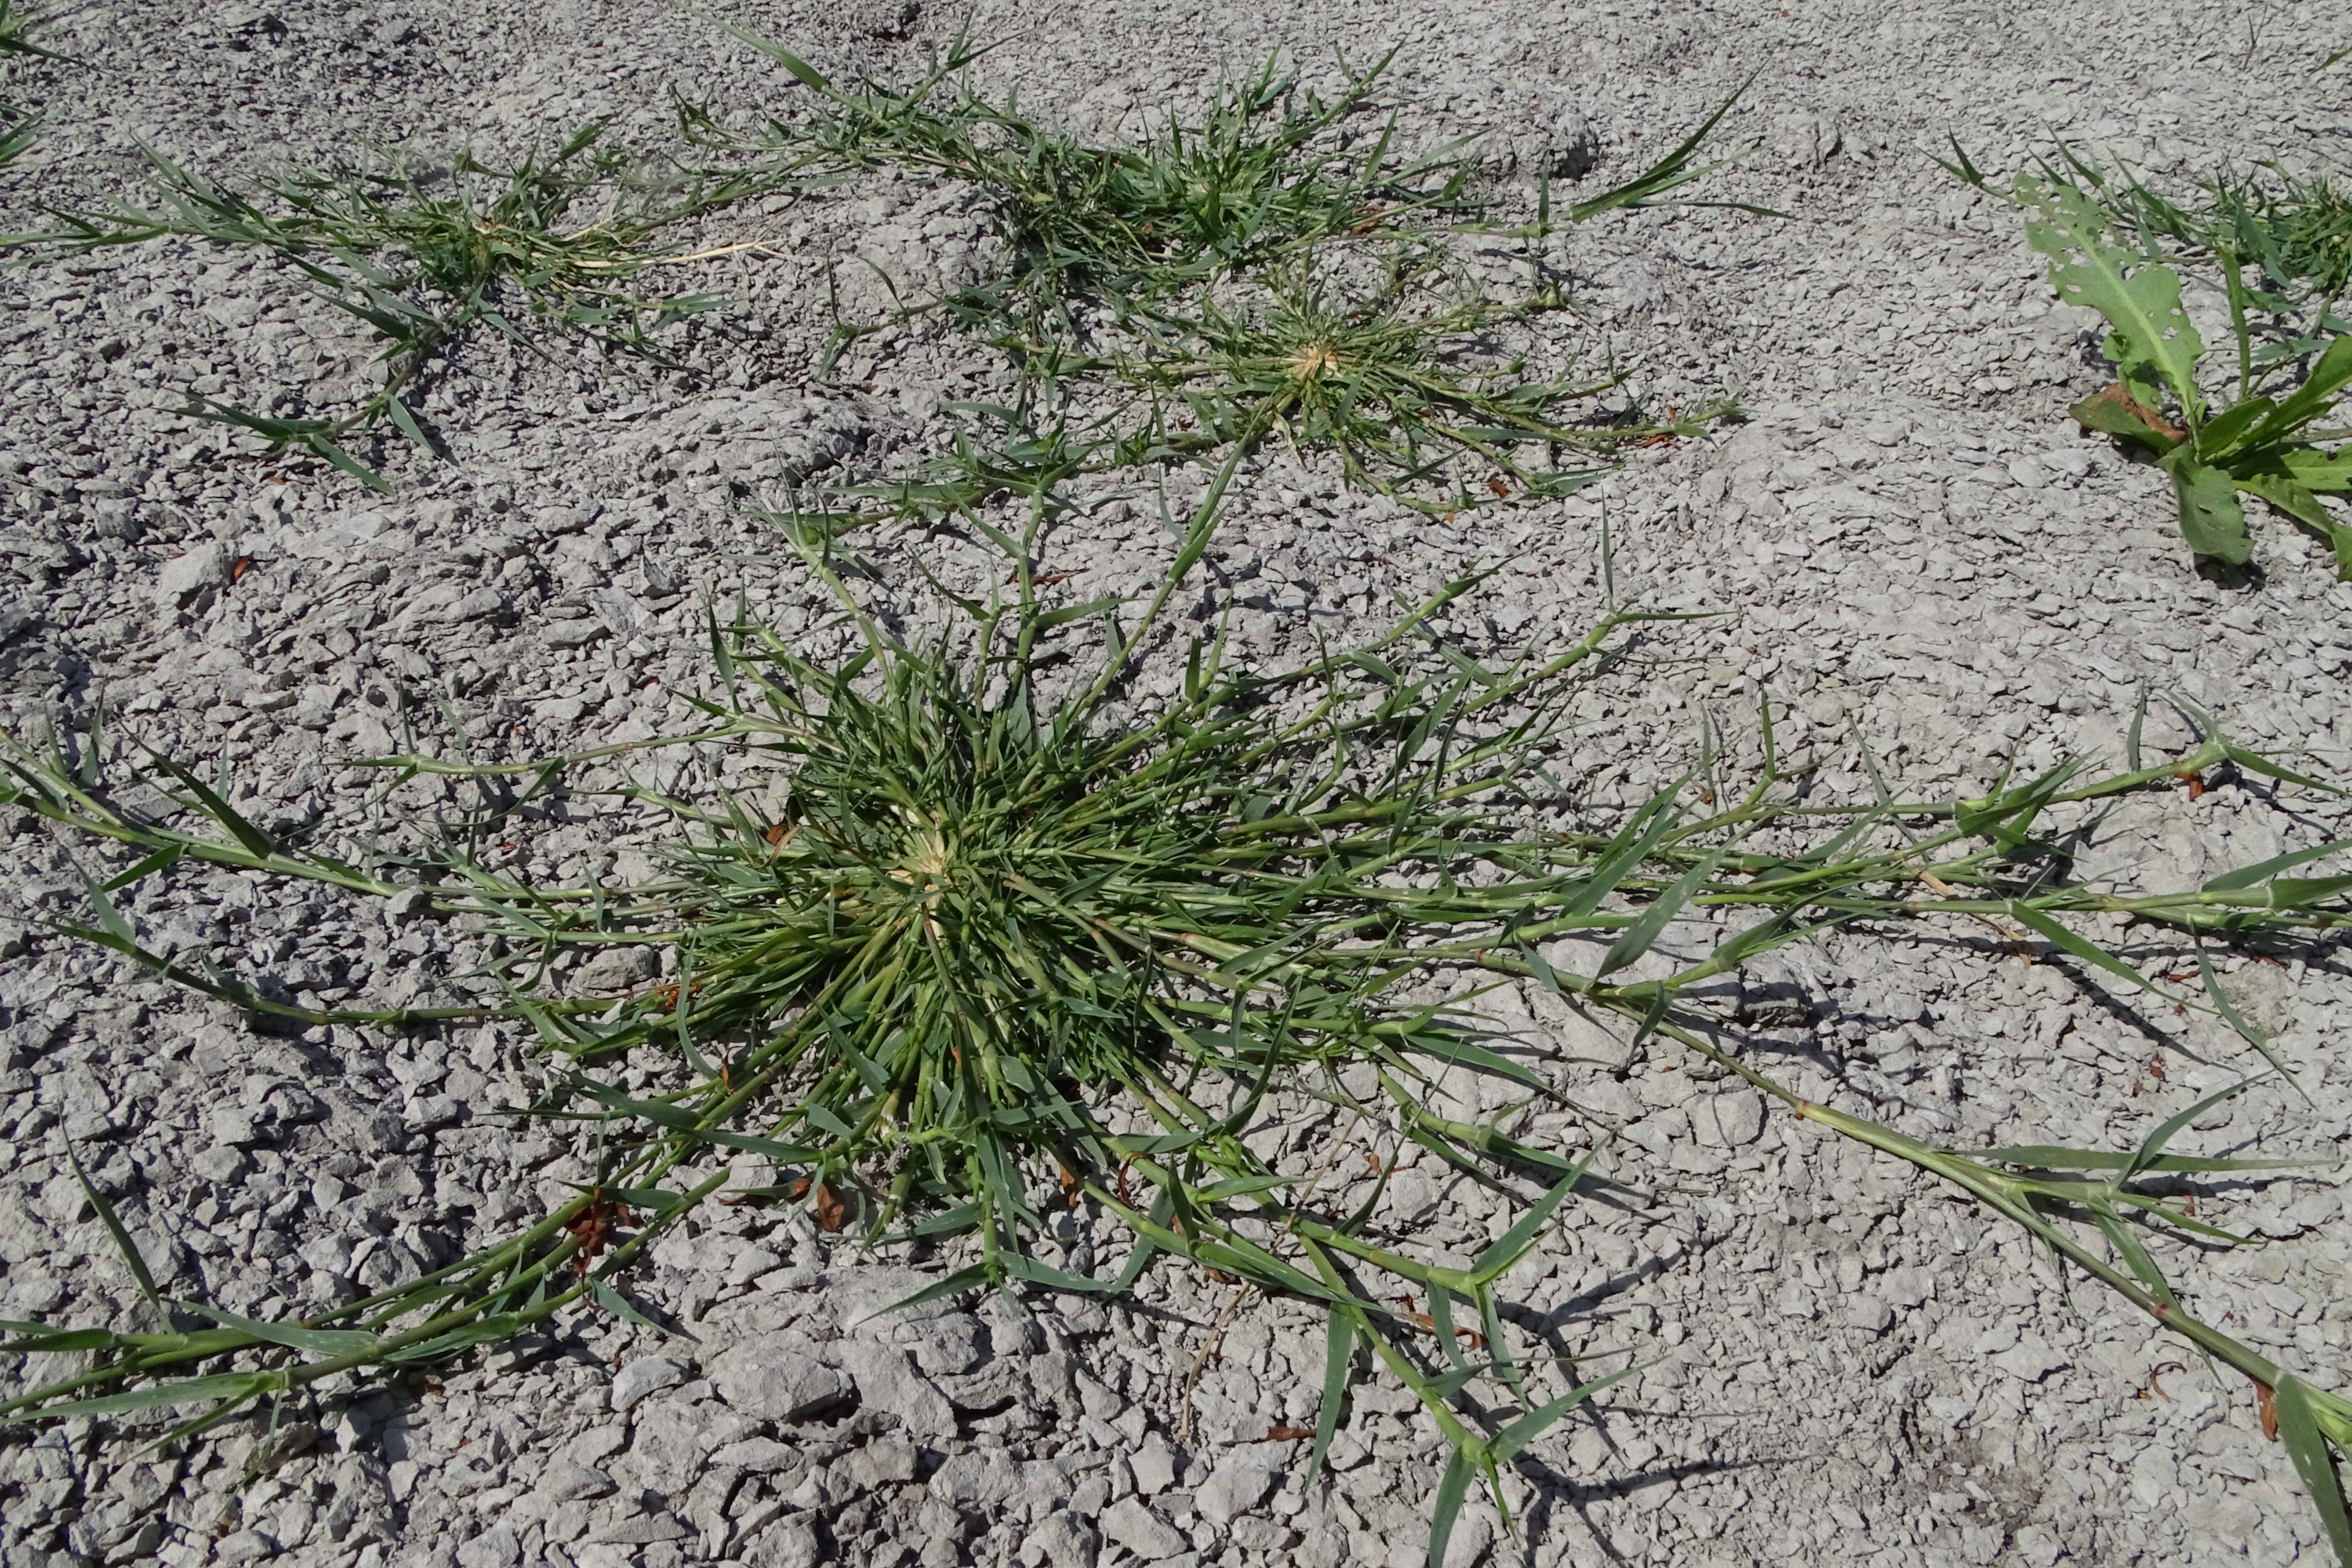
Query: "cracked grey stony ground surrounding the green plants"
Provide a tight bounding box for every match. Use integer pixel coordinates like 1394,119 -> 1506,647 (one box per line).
0,0 -> 2352,1568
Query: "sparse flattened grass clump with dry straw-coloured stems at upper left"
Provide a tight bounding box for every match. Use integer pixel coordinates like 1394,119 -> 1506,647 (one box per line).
14,122 -> 769,489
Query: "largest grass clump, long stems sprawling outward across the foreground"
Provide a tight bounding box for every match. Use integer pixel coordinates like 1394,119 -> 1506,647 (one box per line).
0,463 -> 2352,1563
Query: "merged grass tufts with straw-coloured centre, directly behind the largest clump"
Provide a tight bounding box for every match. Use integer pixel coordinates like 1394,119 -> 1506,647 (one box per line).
706,28 -> 1762,513
